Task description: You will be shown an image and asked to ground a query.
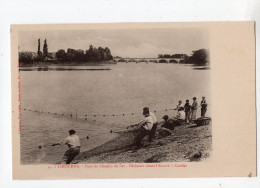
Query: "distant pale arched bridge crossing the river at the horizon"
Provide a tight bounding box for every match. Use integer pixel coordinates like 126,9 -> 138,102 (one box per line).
114,57 -> 184,63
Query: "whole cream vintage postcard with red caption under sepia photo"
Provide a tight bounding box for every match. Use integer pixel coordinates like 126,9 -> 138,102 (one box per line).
11,22 -> 256,179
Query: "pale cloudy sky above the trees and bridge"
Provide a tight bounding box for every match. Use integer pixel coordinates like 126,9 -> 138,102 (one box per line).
19,28 -> 209,58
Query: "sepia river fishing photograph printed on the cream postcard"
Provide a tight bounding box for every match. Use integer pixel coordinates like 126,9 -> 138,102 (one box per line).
18,27 -> 213,165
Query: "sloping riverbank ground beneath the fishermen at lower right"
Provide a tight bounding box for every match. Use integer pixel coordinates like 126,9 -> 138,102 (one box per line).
73,119 -> 212,163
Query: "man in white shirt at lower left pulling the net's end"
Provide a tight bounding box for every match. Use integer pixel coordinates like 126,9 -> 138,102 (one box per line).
52,130 -> 80,164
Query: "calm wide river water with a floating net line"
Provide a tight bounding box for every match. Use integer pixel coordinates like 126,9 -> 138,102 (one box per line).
20,63 -> 210,164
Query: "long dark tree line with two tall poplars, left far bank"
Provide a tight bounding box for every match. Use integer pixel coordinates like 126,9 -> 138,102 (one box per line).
19,39 -> 113,64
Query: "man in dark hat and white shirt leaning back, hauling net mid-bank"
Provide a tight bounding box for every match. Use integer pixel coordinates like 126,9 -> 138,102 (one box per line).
135,107 -> 157,148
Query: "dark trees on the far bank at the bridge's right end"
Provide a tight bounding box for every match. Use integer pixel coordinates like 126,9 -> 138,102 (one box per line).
158,49 -> 209,65
